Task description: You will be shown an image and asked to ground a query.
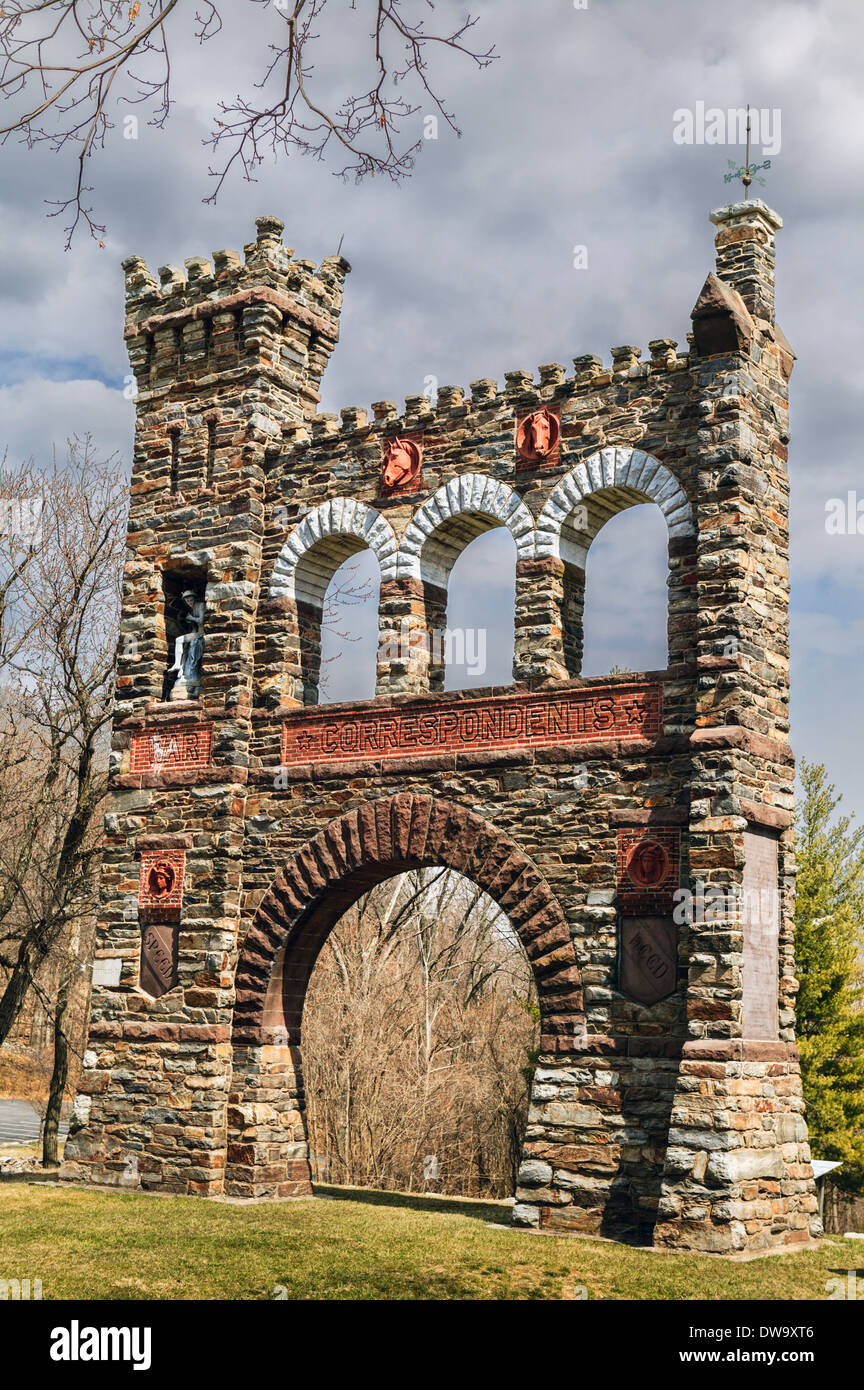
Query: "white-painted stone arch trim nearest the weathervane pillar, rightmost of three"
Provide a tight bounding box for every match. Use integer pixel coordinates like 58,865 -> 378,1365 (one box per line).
536,445 -> 696,567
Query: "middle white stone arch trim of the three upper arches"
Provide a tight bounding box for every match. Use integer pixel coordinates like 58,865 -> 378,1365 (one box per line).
396,473 -> 535,587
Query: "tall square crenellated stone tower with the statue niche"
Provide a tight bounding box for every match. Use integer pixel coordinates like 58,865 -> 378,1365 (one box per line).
64,218 -> 347,1195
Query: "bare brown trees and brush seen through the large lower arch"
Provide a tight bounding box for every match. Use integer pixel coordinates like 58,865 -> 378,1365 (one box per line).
303,869 -> 538,1197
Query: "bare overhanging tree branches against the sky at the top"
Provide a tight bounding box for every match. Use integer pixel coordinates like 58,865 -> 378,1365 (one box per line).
0,0 -> 495,246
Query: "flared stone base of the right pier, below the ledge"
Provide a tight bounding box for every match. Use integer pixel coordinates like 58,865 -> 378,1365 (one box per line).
513,1037 -> 821,1255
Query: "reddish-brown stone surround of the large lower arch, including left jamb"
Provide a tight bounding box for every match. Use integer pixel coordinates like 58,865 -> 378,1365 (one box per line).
225,792 -> 583,1197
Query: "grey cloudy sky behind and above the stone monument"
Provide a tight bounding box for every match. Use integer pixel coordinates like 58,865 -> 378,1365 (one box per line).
0,0 -> 864,815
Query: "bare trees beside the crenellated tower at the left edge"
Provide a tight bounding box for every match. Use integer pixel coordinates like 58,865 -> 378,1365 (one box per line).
0,438 -> 128,1152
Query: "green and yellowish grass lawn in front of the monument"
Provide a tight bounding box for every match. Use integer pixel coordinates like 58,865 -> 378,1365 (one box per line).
0,1183 -> 857,1300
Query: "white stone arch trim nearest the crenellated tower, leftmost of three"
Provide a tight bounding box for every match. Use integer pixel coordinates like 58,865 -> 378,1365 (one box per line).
269,498 -> 397,605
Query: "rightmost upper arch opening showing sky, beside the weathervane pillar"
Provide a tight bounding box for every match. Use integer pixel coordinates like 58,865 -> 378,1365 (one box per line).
578,495 -> 668,676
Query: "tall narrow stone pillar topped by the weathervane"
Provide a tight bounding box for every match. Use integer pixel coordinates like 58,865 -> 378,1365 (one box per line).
654,200 -> 820,1254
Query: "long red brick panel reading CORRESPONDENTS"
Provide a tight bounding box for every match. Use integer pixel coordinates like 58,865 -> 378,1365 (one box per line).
282,684 -> 663,767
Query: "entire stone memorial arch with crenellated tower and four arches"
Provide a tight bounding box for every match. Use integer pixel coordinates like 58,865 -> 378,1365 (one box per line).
64,200 -> 818,1254
